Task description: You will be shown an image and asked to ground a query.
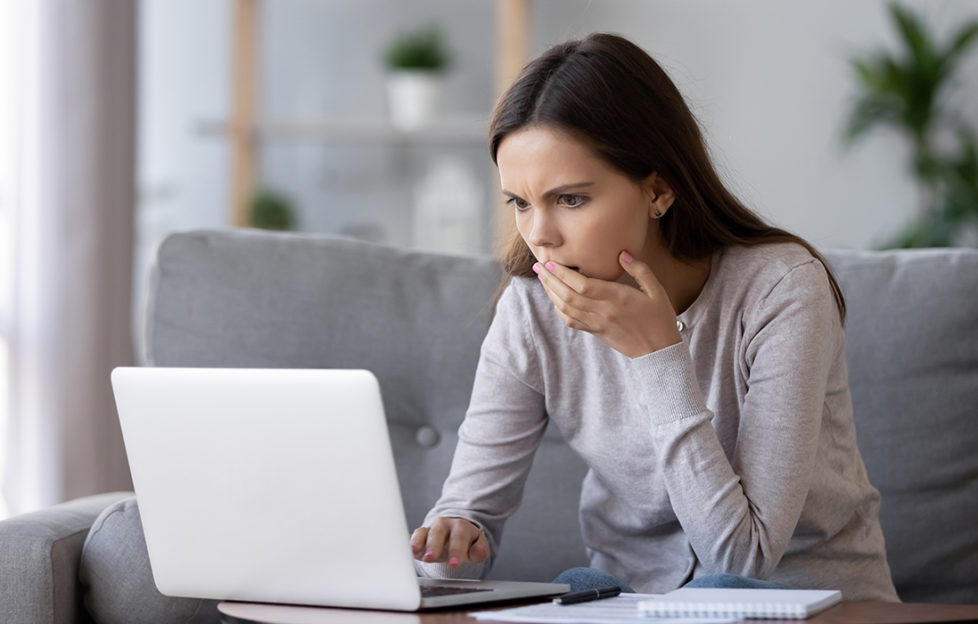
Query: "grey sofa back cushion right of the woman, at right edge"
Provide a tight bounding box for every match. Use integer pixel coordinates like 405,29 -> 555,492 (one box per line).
828,249 -> 978,603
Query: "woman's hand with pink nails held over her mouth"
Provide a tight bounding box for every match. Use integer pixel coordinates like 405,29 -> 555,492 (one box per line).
533,251 -> 682,358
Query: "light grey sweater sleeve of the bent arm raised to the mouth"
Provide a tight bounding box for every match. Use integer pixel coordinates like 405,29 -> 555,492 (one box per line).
633,260 -> 841,578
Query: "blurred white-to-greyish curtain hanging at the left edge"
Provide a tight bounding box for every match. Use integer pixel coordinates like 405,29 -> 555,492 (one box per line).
0,0 -> 137,513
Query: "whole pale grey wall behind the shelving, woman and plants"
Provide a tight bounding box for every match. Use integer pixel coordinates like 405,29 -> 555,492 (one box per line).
137,0 -> 978,279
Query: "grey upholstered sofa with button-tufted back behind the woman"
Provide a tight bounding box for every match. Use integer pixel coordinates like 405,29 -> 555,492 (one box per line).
0,230 -> 978,624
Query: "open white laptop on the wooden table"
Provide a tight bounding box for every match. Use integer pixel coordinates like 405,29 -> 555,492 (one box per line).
112,367 -> 569,611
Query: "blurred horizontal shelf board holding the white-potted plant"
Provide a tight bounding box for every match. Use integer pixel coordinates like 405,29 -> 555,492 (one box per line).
197,117 -> 489,146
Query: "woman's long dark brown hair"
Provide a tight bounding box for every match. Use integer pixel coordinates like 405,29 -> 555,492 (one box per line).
489,33 -> 846,321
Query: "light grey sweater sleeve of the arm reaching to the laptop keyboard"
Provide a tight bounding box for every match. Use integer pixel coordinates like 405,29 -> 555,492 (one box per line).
415,280 -> 547,578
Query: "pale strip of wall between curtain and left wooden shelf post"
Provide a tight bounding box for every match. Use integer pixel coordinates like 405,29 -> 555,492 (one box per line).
133,0 -> 231,352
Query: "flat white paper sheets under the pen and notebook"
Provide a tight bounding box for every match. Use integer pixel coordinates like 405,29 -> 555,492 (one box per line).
469,594 -> 738,624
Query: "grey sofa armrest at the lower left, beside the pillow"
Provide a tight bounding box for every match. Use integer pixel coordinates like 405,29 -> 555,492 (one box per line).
0,492 -> 132,624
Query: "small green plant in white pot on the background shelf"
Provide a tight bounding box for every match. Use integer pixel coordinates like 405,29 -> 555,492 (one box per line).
384,26 -> 451,130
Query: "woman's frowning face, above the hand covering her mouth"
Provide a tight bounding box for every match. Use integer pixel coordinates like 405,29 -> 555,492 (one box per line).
496,126 -> 653,281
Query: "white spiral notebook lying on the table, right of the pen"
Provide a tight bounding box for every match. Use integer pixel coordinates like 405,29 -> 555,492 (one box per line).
638,587 -> 842,619
